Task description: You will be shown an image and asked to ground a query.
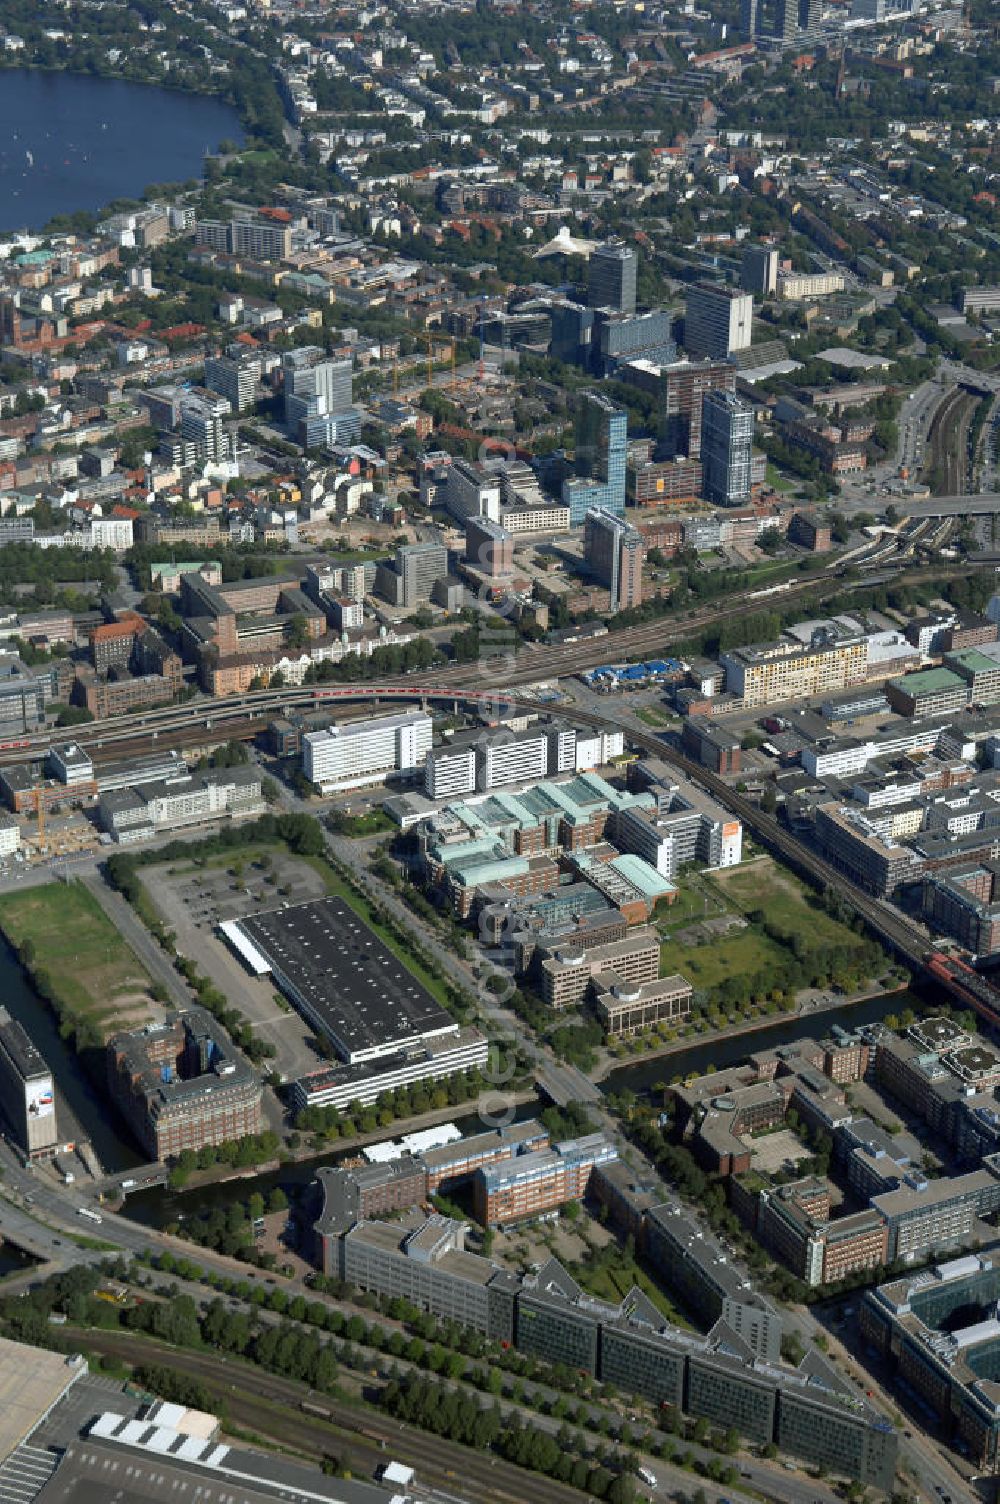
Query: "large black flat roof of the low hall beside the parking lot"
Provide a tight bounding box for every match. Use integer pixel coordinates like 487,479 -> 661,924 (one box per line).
239,898 -> 456,1060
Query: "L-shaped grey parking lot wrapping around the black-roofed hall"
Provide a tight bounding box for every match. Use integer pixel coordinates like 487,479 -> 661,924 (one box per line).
143,851 -> 325,1080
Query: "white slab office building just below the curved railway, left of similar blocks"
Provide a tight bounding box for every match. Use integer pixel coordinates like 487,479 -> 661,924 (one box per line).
302,710 -> 433,791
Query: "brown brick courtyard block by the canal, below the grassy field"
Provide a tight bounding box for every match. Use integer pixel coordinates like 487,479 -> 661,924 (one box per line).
107,1008 -> 265,1161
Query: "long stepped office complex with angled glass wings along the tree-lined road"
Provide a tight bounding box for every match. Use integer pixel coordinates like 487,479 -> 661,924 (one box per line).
303,1185 -> 898,1492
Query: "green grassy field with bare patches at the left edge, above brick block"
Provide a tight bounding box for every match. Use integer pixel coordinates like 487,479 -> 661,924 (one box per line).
0,883 -> 150,1039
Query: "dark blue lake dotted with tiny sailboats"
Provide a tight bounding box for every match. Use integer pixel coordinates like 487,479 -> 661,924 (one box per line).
0,68 -> 244,230
